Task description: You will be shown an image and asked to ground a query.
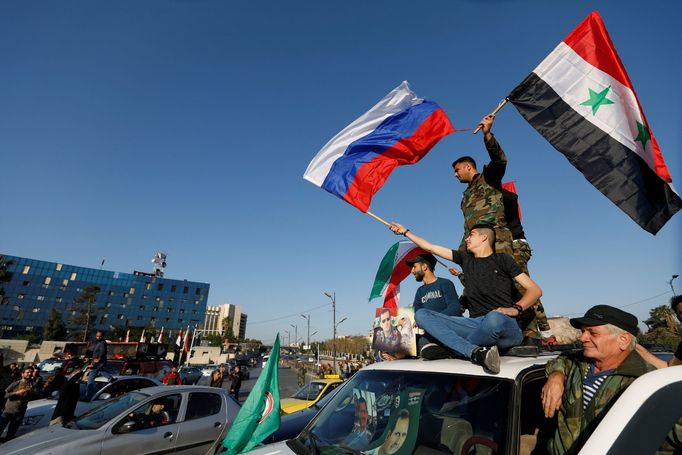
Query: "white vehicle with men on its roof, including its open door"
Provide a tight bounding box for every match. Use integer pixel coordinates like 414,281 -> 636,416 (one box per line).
243,354 -> 682,455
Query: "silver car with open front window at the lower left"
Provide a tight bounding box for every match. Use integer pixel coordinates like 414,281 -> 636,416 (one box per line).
2,386 -> 239,455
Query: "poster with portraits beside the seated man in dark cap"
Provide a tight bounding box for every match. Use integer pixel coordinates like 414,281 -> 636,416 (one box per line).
372,308 -> 417,356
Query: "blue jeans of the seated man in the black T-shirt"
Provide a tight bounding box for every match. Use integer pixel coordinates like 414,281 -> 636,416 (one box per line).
414,308 -> 523,359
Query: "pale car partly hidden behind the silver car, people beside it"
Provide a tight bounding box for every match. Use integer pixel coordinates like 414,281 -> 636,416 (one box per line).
17,374 -> 161,435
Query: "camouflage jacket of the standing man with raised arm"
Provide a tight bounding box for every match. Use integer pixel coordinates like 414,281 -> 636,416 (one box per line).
459,136 -> 512,254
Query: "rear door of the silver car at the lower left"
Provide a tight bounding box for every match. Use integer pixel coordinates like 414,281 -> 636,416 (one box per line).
175,391 -> 227,454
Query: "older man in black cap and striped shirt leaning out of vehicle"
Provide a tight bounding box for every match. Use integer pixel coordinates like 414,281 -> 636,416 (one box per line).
542,305 -> 653,454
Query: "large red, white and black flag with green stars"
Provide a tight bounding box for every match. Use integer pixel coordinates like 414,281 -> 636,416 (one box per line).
509,12 -> 682,234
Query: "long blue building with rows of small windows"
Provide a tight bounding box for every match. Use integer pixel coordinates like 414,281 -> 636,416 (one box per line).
0,255 -> 210,338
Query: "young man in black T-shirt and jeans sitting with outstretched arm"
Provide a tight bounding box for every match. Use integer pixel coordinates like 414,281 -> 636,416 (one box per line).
389,223 -> 542,374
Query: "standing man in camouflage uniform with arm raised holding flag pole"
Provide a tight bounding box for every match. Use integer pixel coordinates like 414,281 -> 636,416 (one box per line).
451,114 -> 549,339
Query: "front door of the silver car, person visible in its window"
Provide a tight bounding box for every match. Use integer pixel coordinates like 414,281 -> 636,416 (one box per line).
101,393 -> 182,455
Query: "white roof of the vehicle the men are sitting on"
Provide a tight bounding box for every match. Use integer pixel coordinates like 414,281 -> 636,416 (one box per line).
362,352 -> 558,379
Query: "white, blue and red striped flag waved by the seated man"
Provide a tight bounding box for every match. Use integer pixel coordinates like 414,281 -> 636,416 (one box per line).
303,81 -> 455,212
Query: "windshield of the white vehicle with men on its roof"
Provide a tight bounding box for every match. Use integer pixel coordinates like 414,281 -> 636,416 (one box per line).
289,371 -> 513,455
